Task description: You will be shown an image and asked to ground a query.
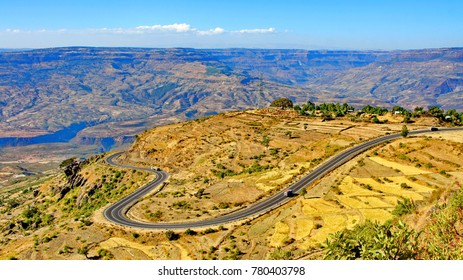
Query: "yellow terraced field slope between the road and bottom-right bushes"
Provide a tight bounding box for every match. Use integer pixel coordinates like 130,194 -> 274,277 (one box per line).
252,135 -> 463,258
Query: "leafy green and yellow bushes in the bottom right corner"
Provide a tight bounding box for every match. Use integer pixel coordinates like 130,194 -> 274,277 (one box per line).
323,182 -> 463,260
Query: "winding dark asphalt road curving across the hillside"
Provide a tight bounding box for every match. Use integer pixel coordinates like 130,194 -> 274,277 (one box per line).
103,128 -> 463,229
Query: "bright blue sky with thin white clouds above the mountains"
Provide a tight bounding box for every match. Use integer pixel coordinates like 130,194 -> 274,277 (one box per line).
0,0 -> 463,50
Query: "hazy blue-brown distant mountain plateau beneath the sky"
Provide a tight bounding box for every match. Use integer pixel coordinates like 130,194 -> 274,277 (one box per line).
0,47 -> 463,137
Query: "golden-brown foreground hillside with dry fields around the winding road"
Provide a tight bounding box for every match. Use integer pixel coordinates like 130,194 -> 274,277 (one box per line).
0,108 -> 463,260
